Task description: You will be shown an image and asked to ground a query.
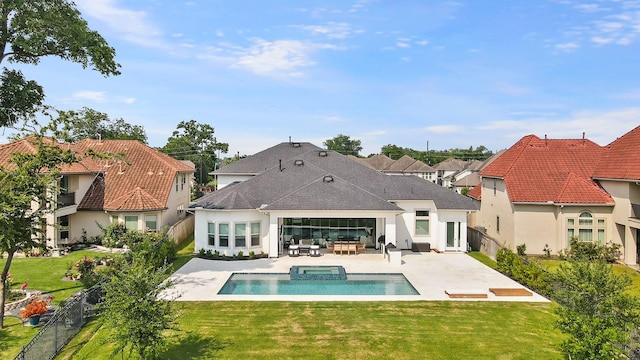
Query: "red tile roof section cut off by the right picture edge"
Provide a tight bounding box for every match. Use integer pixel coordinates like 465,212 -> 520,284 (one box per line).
593,126 -> 640,181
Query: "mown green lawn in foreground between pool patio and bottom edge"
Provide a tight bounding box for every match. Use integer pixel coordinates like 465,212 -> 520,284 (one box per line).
58,301 -> 563,360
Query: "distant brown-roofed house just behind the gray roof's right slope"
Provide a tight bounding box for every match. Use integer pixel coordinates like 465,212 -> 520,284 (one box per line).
348,154 -> 435,182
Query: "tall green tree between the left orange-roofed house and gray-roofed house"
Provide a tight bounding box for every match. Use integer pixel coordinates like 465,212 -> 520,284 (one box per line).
160,120 -> 229,185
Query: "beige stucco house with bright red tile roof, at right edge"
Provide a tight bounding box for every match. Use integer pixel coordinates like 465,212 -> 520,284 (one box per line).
469,127 -> 640,264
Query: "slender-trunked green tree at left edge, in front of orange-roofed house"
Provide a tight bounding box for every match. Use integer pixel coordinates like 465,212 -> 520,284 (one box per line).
0,130 -> 76,329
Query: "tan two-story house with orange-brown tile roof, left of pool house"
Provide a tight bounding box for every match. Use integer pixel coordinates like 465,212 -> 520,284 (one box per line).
0,139 -> 195,248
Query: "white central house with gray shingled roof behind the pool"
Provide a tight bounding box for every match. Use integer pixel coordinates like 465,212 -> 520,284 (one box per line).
190,142 -> 475,257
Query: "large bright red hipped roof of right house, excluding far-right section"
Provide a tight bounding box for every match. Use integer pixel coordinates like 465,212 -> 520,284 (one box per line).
474,135 -> 613,204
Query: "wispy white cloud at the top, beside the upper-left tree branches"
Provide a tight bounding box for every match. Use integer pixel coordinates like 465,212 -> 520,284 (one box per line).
76,0 -> 166,48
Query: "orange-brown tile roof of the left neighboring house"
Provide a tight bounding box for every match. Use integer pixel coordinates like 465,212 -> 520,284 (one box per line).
0,139 -> 195,211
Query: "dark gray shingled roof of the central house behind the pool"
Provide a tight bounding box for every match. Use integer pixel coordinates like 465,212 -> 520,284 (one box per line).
191,143 -> 476,211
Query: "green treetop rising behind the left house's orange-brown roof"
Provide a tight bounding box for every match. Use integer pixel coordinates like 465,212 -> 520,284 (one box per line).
59,107 -> 147,144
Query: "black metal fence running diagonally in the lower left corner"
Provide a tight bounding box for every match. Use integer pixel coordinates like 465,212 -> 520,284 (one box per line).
15,284 -> 102,360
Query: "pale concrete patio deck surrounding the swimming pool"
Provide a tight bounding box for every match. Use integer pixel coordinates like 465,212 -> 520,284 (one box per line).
161,249 -> 549,302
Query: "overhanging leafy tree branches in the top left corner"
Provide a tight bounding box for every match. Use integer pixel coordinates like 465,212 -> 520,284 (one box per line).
0,0 -> 120,126
